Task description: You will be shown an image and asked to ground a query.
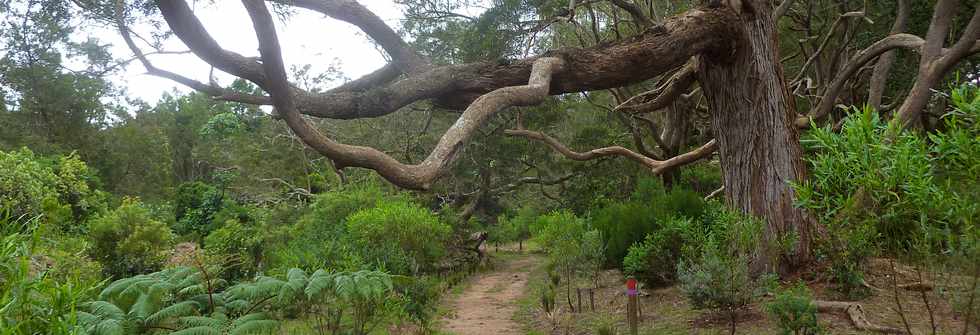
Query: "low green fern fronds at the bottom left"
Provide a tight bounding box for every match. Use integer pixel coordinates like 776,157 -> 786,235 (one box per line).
79,267 -> 281,335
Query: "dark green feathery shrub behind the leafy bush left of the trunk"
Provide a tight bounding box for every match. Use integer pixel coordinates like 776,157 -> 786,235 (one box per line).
591,178 -> 704,266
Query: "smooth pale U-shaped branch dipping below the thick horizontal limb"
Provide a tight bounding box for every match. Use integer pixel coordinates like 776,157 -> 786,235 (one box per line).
242,0 -> 563,190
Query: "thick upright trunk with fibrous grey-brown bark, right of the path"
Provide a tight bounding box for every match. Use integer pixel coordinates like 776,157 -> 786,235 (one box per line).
699,0 -> 814,273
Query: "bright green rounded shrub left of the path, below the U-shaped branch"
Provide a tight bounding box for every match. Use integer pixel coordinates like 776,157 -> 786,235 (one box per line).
347,201 -> 452,274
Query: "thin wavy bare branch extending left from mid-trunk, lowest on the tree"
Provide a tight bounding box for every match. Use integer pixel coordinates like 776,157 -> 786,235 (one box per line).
504,129 -> 718,174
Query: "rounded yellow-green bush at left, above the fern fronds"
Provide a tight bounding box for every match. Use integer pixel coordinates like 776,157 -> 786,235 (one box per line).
89,198 -> 173,277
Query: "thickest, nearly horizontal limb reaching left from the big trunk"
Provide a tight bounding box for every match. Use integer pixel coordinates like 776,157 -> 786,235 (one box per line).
158,0 -> 738,119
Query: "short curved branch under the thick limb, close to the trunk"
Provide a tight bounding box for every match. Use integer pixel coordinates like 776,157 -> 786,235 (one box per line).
613,58 -> 697,114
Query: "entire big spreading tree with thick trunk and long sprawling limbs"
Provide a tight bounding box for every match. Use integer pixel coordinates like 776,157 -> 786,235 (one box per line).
101,0 -> 980,266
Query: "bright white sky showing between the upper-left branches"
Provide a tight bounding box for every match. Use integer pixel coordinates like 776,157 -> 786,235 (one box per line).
83,0 -> 402,103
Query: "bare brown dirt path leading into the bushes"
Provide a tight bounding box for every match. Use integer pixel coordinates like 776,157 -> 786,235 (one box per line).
442,254 -> 539,335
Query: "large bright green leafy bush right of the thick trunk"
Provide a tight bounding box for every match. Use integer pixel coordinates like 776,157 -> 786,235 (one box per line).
794,84 -> 980,299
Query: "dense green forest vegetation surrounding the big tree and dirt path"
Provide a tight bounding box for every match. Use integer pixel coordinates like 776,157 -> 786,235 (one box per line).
0,0 -> 980,335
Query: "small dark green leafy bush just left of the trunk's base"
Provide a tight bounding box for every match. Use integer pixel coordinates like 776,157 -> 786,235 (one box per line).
623,217 -> 694,285
